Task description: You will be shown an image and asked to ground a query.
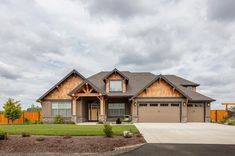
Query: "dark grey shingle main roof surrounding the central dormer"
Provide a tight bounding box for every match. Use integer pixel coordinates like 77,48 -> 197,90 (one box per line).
88,71 -> 214,101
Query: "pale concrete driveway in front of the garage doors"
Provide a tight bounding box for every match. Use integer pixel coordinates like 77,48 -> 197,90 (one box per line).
135,123 -> 235,144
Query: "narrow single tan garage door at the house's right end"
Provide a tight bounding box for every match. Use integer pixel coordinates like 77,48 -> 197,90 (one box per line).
188,103 -> 204,122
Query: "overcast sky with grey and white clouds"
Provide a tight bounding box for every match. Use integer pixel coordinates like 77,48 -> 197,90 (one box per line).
0,0 -> 235,110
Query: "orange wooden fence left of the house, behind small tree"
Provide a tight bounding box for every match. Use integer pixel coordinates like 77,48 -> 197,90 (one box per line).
0,112 -> 42,124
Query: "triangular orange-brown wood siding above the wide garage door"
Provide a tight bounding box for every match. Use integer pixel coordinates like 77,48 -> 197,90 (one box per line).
138,80 -> 183,97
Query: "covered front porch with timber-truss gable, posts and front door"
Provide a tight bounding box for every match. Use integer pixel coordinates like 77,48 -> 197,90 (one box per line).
70,82 -> 131,123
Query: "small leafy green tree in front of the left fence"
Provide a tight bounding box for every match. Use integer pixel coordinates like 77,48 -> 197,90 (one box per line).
3,98 -> 22,123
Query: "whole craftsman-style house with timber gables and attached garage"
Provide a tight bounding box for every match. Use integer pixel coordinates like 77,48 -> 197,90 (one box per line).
37,69 -> 215,123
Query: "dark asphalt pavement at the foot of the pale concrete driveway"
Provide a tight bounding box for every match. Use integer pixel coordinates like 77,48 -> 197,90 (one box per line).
120,144 -> 235,156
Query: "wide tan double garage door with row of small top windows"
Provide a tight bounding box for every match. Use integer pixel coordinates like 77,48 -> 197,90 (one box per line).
138,103 -> 180,122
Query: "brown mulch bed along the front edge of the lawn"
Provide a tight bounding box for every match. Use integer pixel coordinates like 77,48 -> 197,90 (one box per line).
0,136 -> 145,153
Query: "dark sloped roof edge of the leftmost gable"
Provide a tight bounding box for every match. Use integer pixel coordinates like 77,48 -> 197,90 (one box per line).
37,69 -> 86,102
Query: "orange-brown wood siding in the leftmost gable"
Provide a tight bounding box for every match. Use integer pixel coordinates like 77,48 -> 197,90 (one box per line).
44,75 -> 82,100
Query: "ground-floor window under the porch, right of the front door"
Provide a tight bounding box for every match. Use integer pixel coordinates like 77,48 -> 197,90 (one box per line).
108,103 -> 125,116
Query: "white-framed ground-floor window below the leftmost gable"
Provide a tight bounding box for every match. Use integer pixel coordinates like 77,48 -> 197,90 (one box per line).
52,101 -> 71,117
